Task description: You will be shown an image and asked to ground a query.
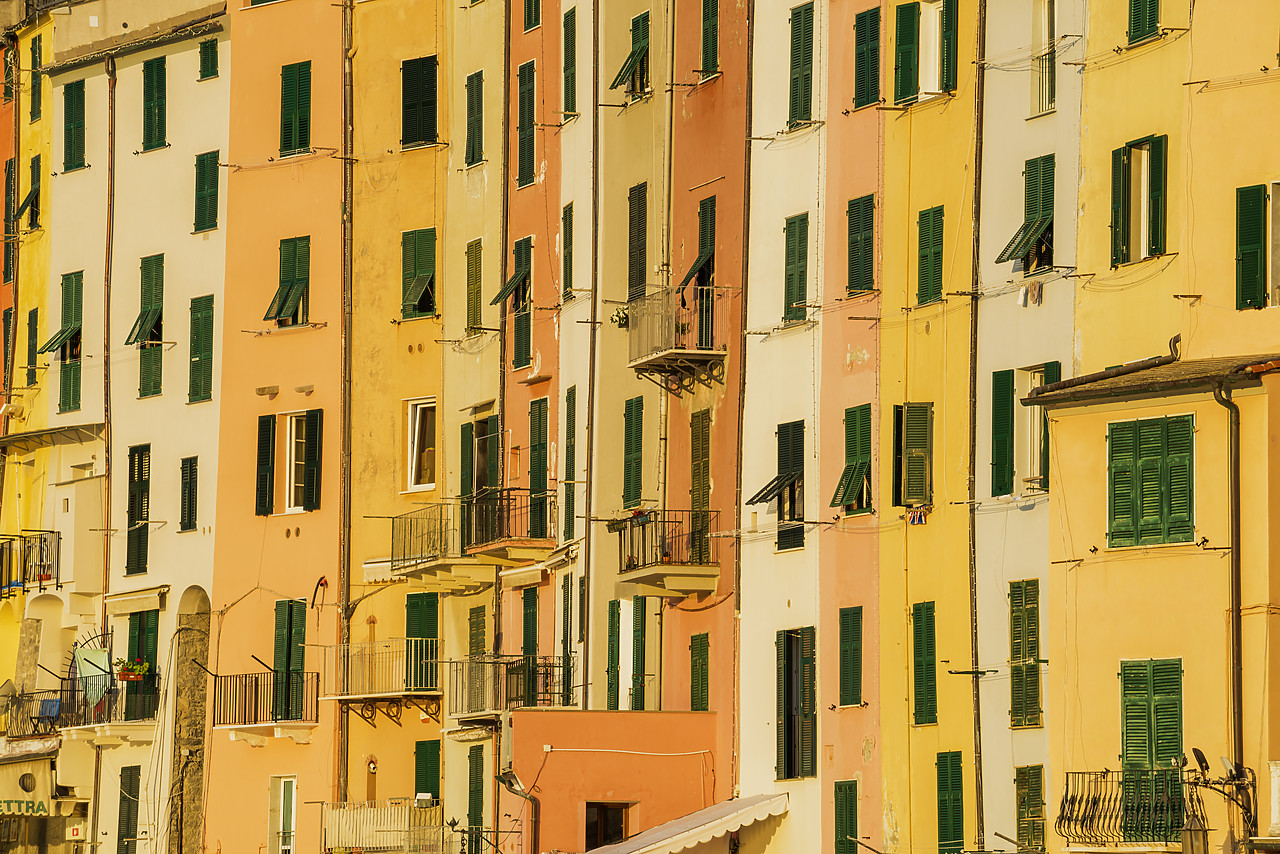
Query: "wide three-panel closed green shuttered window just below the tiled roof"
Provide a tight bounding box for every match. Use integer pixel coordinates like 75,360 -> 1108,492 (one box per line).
1107,415 -> 1194,548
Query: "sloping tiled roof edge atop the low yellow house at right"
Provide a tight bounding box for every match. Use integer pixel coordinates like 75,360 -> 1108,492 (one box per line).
1023,353 -> 1280,406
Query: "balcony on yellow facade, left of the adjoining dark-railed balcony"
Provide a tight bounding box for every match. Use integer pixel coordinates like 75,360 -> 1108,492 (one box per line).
392,501 -> 497,594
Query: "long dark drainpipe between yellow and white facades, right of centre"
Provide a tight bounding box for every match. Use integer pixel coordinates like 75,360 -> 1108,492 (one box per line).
969,0 -> 987,851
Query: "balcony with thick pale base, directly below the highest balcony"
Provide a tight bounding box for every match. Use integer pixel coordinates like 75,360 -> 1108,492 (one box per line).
608,510 -> 719,595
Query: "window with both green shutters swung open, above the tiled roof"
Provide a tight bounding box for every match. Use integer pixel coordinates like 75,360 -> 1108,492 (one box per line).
1111,136 -> 1169,266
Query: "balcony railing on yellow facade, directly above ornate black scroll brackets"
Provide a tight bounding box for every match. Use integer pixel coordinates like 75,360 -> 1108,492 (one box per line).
326,638 -> 440,697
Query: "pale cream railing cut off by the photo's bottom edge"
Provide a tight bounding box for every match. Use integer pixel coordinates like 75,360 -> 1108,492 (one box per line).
320,798 -> 458,854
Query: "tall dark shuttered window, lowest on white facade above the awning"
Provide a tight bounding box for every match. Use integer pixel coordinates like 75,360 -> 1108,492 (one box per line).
776,626 -> 818,780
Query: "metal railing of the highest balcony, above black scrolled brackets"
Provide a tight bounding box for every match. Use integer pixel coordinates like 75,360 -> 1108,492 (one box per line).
627,282 -> 730,361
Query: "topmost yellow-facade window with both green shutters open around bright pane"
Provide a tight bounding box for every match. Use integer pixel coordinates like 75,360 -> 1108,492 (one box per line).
893,0 -> 959,104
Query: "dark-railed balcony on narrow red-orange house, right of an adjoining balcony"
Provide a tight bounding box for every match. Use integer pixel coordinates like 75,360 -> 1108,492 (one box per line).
461,488 -> 556,565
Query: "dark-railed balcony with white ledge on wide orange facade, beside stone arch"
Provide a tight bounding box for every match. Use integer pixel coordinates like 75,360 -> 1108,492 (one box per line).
214,671 -> 320,746
